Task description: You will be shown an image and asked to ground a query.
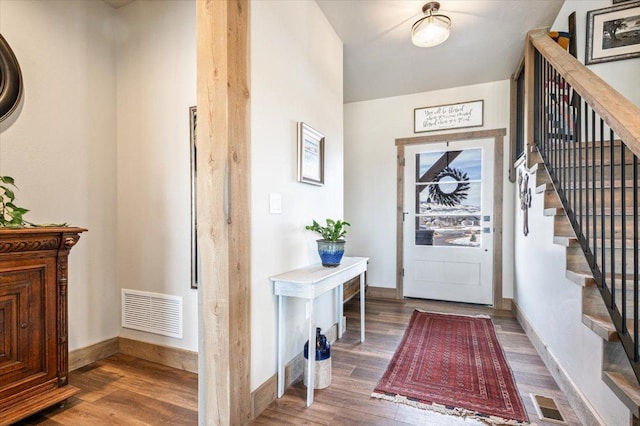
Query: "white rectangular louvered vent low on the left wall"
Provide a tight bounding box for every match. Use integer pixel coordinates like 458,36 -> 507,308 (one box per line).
122,289 -> 182,339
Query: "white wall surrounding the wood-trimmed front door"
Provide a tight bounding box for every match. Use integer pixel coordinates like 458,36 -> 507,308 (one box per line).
344,80 -> 513,298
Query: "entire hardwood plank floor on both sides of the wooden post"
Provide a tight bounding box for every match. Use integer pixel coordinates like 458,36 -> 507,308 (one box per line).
20,298 -> 580,426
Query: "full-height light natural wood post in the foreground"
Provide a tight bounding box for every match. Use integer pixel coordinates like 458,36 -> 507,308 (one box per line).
196,0 -> 251,425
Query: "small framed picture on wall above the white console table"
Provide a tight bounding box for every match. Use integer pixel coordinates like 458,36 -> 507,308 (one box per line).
298,122 -> 324,186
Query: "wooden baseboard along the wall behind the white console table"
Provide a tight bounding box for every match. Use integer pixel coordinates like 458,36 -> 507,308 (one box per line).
251,320 -> 342,419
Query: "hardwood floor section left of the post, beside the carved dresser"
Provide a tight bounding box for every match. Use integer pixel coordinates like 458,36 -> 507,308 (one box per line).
19,355 -> 198,426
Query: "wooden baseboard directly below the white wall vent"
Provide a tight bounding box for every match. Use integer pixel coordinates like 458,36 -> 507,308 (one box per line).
119,337 -> 198,373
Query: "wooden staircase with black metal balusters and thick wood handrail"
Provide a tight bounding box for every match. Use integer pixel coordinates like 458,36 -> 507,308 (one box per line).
525,31 -> 640,425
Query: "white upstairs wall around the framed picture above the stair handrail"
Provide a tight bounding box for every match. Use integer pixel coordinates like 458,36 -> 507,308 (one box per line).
551,0 -> 640,106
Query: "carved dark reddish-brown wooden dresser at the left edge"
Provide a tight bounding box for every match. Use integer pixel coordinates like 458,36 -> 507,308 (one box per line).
0,227 -> 86,425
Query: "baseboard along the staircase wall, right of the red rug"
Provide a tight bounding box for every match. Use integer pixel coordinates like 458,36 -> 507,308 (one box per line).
511,300 -> 604,425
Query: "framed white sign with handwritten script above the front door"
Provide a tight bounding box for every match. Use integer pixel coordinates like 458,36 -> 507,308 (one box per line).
413,100 -> 484,133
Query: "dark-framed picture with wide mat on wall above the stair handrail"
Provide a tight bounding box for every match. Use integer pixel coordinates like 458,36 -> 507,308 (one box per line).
585,1 -> 640,65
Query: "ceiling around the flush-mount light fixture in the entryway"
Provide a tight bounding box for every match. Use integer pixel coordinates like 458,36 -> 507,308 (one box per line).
316,0 -> 564,103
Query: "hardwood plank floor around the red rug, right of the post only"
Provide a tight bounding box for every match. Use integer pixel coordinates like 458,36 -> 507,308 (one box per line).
253,298 -> 580,426
